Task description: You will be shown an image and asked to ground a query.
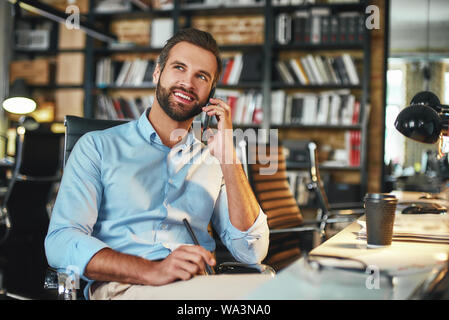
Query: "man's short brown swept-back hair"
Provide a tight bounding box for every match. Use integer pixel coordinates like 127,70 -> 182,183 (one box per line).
157,28 -> 222,87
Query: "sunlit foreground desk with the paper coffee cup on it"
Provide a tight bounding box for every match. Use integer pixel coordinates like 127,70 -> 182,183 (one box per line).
245,216 -> 449,300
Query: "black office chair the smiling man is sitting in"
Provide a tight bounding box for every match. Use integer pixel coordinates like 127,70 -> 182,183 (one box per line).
44,116 -> 275,300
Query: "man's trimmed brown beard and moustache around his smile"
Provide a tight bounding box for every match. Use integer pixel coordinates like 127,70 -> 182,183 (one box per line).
156,79 -> 207,122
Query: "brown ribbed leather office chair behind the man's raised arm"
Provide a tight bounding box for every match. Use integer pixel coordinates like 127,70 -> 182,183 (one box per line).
246,141 -> 319,271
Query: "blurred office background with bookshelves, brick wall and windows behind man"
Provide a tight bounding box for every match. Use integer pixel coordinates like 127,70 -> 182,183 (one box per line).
0,0 -> 449,298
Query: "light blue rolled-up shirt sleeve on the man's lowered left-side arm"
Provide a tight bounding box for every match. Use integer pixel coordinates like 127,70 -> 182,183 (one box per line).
45,134 -> 107,279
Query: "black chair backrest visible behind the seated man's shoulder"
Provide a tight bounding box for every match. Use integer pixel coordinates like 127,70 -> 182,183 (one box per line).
64,116 -> 128,165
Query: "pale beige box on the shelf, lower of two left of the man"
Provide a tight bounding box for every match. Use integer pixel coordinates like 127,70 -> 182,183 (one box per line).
55,89 -> 84,122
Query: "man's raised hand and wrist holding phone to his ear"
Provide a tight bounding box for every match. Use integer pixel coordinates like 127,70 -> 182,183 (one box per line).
203,98 -> 236,164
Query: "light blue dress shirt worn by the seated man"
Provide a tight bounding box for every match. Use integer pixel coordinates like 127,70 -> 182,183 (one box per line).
45,109 -> 269,295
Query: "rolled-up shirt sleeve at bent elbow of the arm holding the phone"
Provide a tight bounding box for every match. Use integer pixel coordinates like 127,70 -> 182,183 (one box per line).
212,184 -> 269,264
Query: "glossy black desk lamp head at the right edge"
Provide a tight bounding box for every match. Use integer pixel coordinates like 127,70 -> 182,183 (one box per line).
394,91 -> 449,144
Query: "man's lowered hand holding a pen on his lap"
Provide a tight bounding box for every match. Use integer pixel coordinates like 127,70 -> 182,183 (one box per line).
143,245 -> 215,286
